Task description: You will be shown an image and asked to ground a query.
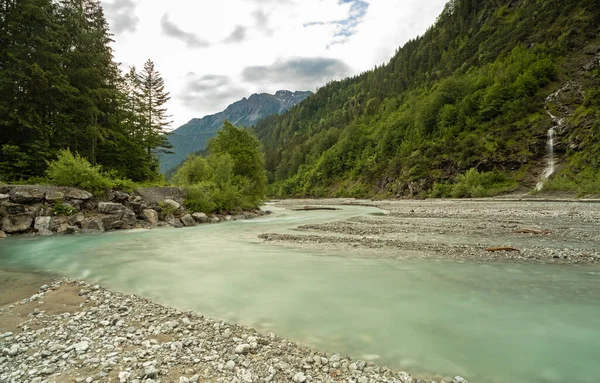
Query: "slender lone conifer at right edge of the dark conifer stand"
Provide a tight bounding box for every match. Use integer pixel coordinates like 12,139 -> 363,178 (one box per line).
139,60 -> 171,156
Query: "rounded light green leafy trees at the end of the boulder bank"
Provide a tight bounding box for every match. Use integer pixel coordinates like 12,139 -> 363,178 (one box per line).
173,121 -> 266,213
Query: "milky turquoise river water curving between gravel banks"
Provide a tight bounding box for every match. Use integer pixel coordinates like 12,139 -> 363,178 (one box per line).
0,207 -> 600,383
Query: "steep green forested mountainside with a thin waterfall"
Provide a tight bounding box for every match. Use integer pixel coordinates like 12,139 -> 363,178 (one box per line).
256,0 -> 600,197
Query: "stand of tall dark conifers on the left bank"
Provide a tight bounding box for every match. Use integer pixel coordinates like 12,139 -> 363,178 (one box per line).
0,0 -> 170,183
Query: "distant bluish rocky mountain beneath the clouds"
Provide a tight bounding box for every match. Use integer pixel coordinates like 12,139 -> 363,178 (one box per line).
160,90 -> 313,173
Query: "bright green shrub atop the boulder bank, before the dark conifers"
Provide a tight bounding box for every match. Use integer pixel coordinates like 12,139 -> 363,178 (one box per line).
47,149 -> 115,194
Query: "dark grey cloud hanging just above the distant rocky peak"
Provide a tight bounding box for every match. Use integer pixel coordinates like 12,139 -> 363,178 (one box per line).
242,57 -> 352,84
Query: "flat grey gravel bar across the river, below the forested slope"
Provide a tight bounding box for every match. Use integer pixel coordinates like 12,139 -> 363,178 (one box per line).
260,199 -> 600,264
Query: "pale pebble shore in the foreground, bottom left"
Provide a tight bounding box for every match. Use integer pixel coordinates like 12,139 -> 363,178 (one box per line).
0,279 -> 466,383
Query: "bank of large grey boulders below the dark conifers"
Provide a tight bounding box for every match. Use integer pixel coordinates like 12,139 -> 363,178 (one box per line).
0,186 -> 263,238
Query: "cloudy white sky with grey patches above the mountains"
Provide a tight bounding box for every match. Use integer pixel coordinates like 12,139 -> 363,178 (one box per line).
102,0 -> 446,129
